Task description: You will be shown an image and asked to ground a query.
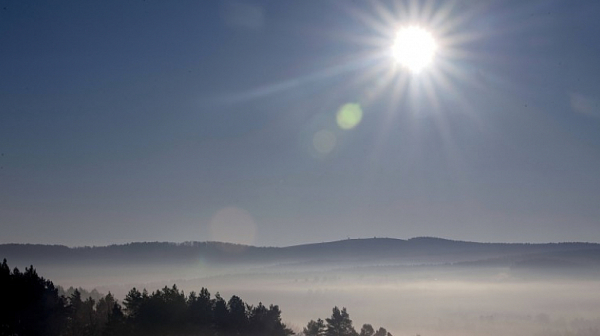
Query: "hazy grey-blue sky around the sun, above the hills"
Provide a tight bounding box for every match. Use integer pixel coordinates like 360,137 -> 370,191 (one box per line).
0,0 -> 600,245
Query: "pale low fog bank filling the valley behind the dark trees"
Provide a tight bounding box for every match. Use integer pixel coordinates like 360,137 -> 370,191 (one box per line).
39,266 -> 600,336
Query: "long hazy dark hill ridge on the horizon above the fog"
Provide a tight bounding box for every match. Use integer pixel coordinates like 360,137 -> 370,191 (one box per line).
0,237 -> 600,267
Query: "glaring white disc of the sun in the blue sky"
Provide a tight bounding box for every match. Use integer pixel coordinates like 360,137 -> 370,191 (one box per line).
392,26 -> 437,73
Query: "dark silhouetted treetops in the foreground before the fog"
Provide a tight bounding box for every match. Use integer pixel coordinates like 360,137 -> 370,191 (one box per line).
0,259 -> 391,336
